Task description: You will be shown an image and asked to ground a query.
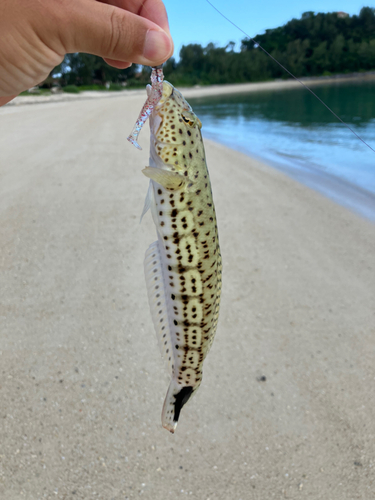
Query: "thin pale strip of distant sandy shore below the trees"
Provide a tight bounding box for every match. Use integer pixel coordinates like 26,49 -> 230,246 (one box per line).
3,71 -> 375,107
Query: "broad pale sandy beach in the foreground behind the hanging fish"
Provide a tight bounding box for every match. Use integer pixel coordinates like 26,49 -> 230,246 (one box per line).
0,89 -> 375,500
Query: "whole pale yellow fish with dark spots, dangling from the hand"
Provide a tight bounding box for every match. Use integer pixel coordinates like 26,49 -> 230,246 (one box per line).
129,68 -> 222,433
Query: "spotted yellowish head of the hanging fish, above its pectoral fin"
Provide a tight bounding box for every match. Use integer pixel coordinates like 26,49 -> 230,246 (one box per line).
150,81 -> 203,171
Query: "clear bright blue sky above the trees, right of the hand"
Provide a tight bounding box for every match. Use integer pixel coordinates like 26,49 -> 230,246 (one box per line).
164,0 -> 372,59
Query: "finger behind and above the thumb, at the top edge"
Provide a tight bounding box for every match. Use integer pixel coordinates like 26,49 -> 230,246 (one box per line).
99,0 -> 170,33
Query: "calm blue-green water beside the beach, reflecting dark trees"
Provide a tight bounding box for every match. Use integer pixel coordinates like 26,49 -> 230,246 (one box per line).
189,82 -> 375,220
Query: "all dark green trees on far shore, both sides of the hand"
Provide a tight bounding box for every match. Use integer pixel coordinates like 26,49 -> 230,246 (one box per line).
53,7 -> 375,88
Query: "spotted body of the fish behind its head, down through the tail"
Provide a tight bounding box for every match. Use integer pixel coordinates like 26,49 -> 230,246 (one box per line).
145,166 -> 222,432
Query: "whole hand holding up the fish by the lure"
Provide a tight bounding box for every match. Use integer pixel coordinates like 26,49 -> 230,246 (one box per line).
0,0 -> 173,106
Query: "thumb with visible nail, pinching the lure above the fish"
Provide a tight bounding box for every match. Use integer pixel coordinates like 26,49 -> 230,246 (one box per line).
59,2 -> 173,66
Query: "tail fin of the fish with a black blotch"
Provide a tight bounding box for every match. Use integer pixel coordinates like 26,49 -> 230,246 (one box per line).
161,379 -> 197,434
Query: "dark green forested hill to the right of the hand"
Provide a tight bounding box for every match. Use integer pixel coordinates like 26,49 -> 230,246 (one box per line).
164,7 -> 375,85
